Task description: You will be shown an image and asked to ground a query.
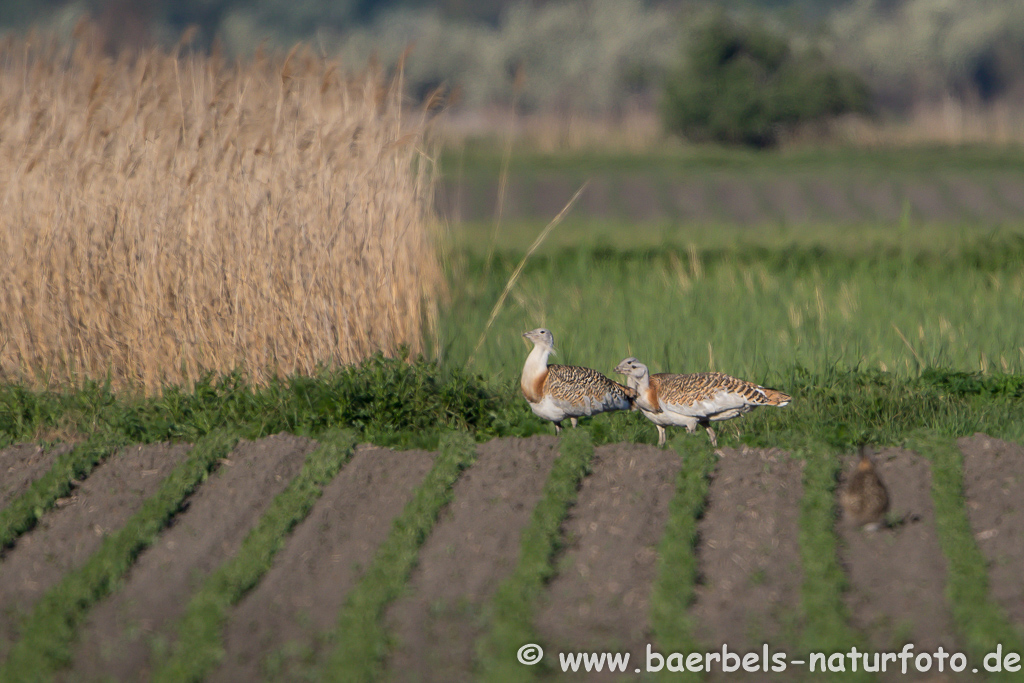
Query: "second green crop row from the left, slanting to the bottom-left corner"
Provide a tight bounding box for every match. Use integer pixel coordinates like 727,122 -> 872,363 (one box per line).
0,431 -> 238,683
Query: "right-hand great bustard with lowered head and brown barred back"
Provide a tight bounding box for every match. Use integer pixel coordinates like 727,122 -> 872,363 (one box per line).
615,357 -> 790,447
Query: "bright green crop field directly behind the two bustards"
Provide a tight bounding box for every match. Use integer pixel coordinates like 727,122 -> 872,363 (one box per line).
439,232 -> 1024,383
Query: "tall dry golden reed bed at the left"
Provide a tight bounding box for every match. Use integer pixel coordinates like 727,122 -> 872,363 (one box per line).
0,28 -> 442,392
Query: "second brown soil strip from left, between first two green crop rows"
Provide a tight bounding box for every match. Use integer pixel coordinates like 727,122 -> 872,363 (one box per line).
0,444 -> 188,659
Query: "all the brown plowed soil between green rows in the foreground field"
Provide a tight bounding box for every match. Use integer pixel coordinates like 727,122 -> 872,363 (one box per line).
0,434 -> 1024,681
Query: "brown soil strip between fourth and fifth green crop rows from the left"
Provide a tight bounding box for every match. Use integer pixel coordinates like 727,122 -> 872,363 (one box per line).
387,436 -> 558,681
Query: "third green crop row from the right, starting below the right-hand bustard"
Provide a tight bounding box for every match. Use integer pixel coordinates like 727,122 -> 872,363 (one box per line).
650,437 -> 716,680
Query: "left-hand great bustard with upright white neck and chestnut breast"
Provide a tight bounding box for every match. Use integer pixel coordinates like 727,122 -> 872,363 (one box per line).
519,328 -> 637,434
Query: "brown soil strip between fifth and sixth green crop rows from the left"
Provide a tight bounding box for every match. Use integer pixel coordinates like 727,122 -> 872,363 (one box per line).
536,444 -> 681,667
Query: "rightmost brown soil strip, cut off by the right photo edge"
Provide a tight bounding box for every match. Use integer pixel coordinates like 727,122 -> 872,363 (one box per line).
959,434 -> 1024,628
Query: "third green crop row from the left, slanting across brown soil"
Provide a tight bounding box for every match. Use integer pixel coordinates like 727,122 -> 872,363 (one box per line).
153,431 -> 356,682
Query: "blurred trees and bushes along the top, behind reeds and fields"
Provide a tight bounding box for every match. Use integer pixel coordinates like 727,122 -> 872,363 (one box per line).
12,0 -> 1024,147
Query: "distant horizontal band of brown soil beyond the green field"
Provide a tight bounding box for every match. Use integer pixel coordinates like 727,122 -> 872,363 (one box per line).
437,173 -> 1024,226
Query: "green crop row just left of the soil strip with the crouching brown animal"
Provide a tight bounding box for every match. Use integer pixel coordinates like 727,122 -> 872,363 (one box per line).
799,443 -> 873,681
